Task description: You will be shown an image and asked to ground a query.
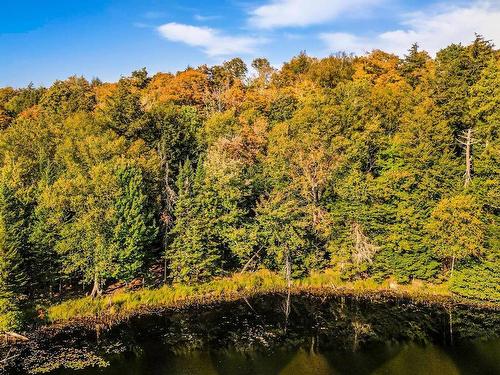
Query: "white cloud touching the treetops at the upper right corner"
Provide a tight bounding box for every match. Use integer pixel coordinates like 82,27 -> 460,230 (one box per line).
320,2 -> 500,55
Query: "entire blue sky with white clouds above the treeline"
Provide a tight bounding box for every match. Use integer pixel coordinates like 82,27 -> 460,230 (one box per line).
0,0 -> 500,87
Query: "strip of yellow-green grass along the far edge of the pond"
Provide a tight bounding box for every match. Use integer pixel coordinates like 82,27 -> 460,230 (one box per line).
46,270 -> 498,323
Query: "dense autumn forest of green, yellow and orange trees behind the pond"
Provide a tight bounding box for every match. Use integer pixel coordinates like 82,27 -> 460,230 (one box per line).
0,35 -> 500,330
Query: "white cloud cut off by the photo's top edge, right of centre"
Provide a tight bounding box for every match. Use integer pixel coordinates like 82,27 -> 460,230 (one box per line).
249,0 -> 382,29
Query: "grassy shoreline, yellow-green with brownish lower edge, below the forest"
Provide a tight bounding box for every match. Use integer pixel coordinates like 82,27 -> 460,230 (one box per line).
36,270 -> 500,329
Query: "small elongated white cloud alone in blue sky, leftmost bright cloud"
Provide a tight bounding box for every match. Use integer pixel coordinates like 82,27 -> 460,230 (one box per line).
158,22 -> 264,56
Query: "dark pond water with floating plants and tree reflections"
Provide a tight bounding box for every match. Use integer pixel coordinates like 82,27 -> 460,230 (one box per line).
8,295 -> 500,375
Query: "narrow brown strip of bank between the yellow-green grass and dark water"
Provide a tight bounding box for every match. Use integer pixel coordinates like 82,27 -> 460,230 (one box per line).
0,286 -> 500,348
